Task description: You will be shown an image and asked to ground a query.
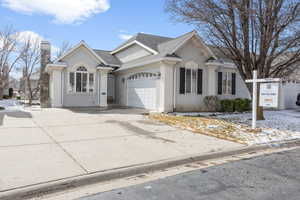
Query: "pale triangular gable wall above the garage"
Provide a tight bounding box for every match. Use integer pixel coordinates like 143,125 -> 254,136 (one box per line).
115,44 -> 151,63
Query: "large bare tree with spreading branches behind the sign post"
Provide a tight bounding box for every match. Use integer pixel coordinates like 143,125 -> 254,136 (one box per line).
166,0 -> 300,119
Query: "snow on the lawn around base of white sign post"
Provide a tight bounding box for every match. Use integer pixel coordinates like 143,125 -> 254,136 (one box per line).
173,109 -> 300,145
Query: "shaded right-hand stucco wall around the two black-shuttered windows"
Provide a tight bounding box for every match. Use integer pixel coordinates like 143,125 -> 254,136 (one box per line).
175,40 -> 250,111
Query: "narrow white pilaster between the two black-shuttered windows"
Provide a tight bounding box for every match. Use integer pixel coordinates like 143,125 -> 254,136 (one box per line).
206,63 -> 218,96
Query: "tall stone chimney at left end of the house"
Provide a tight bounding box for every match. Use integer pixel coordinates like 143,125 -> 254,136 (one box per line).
40,41 -> 51,108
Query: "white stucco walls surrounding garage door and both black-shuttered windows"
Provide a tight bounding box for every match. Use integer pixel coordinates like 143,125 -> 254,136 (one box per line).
116,39 -> 250,112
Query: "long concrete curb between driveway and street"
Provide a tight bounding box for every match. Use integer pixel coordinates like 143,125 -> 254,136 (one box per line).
0,140 -> 300,200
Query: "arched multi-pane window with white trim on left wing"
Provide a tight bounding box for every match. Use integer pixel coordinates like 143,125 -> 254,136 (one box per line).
69,66 -> 94,93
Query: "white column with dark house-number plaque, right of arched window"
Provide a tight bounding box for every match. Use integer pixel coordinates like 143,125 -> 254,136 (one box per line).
98,67 -> 112,107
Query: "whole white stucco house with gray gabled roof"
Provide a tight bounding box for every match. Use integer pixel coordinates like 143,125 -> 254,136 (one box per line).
42,31 -> 250,112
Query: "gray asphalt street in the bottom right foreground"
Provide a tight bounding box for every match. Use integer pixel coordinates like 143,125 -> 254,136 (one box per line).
81,148 -> 300,200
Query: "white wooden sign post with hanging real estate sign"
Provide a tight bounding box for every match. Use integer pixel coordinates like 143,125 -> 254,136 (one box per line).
246,70 -> 281,129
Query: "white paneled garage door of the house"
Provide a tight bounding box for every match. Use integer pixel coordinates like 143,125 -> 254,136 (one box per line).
127,73 -> 159,110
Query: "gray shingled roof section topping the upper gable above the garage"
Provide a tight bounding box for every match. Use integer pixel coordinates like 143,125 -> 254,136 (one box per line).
114,33 -> 173,51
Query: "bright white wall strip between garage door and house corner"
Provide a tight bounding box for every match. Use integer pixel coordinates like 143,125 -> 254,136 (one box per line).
159,62 -> 175,112
